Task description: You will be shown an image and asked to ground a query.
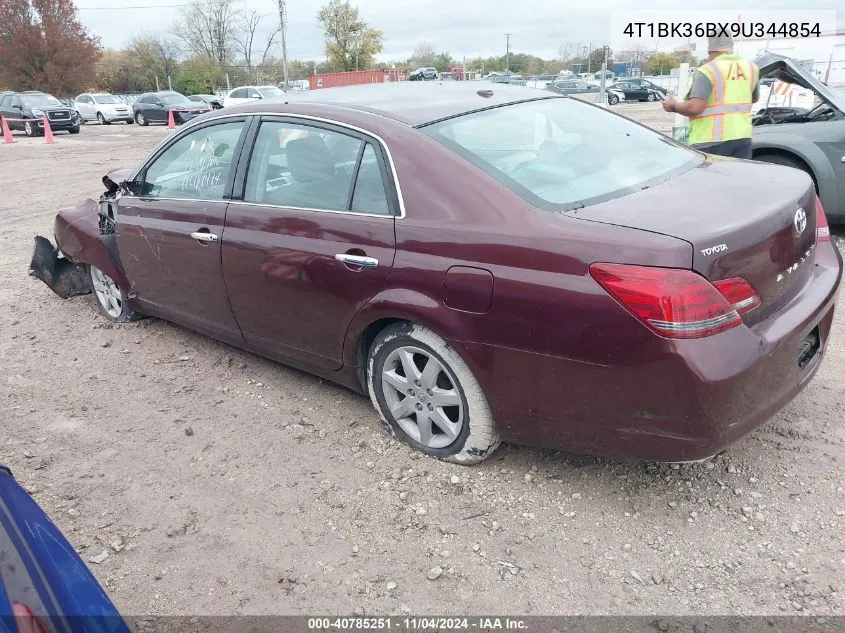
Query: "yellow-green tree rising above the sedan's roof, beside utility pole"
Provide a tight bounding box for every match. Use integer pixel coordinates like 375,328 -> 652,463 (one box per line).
317,0 -> 383,71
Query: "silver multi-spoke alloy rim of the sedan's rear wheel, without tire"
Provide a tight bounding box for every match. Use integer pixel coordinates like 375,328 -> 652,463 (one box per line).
381,346 -> 466,449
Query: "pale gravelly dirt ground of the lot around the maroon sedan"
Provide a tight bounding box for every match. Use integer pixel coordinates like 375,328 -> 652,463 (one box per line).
0,104 -> 845,615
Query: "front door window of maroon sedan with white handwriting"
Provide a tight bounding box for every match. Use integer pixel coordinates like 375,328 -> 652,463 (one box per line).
142,121 -> 245,200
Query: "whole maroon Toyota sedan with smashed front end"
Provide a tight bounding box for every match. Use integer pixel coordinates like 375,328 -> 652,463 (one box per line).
31,82 -> 842,463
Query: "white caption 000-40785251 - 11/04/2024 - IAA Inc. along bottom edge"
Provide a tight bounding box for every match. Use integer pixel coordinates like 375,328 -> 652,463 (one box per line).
308,616 -> 528,632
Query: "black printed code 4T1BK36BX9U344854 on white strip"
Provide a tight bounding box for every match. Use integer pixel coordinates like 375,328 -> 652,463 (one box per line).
622,22 -> 822,38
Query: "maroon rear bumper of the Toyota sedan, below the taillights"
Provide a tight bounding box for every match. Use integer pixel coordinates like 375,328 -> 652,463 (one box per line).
452,243 -> 842,461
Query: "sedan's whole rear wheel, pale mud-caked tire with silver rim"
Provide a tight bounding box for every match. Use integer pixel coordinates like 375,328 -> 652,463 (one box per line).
367,322 -> 501,464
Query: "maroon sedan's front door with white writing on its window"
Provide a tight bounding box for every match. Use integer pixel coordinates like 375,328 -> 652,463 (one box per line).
116,116 -> 248,341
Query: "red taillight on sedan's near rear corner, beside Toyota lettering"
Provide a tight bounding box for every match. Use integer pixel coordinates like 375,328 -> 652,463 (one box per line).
590,264 -> 760,339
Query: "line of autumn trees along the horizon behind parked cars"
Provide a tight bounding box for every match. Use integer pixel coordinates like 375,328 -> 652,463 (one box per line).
0,0 -> 690,96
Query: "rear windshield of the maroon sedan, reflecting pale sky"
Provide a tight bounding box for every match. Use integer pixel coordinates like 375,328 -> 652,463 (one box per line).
421,98 -> 704,211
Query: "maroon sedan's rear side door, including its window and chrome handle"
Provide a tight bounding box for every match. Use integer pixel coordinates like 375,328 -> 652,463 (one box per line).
222,116 -> 400,369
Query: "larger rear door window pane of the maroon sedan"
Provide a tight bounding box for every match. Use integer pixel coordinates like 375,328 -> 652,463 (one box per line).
244,121 -> 363,211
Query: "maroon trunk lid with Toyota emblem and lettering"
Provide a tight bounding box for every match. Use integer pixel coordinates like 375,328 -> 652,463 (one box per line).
566,157 -> 816,324
